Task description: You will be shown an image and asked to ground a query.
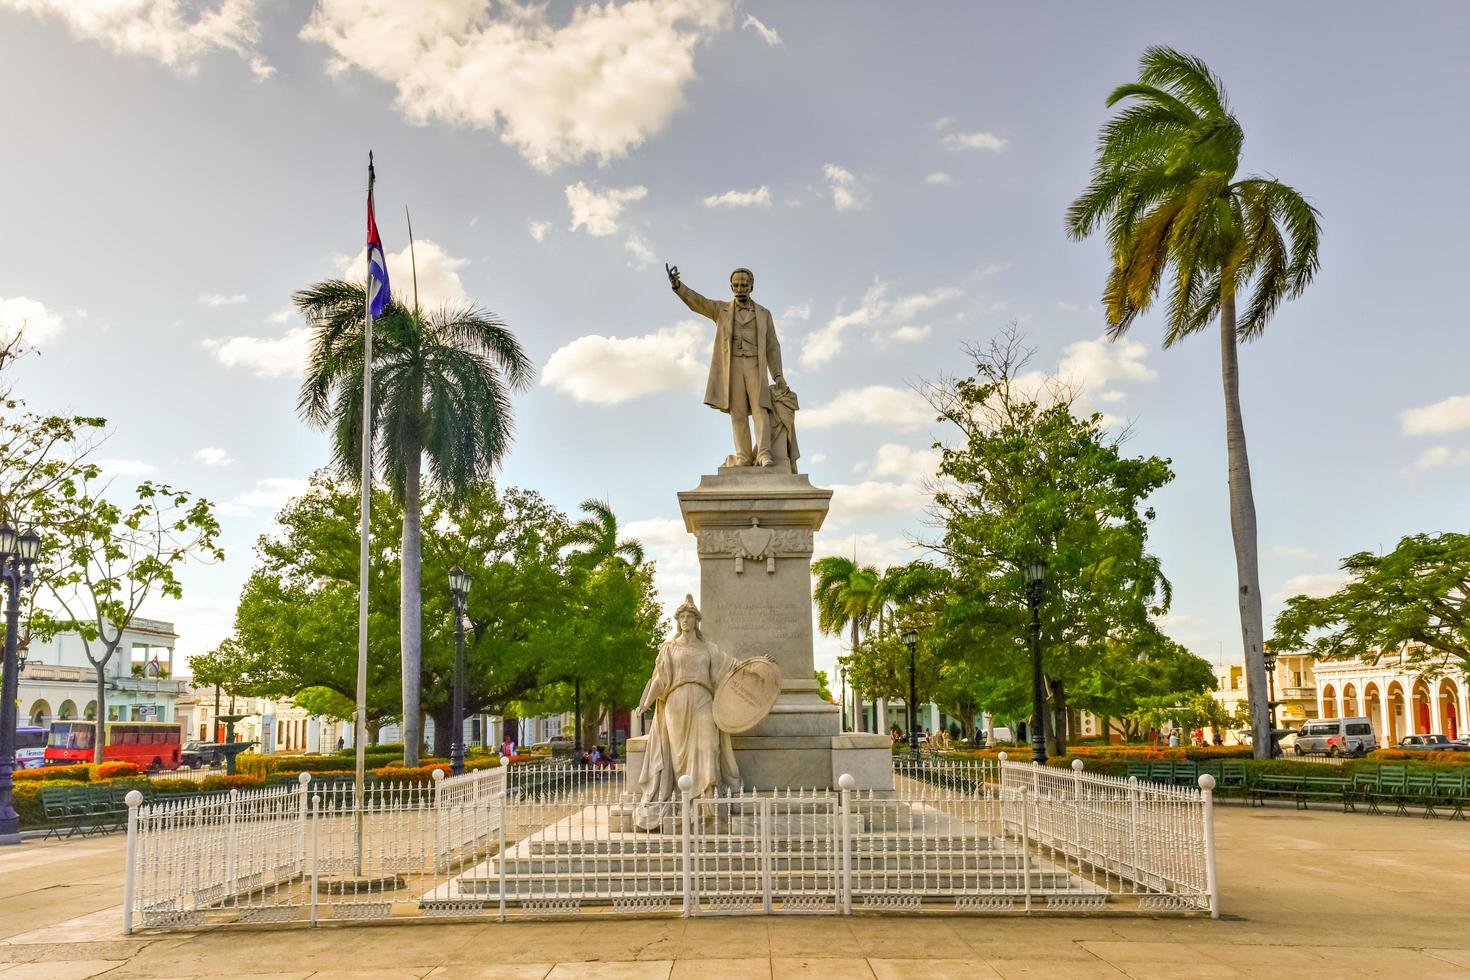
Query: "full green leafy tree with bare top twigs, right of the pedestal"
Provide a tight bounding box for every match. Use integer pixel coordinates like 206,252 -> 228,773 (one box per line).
926,332 -> 1173,752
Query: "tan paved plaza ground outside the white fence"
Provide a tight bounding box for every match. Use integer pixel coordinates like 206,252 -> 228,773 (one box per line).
0,804 -> 1470,980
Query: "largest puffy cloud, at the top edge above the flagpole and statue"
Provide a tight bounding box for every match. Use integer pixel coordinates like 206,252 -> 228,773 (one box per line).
301,0 -> 731,170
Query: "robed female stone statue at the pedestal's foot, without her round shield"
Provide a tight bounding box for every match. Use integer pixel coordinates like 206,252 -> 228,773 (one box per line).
634,595 -> 739,830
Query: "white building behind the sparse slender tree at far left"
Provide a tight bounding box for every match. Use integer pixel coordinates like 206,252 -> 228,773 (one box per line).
18,617 -> 188,726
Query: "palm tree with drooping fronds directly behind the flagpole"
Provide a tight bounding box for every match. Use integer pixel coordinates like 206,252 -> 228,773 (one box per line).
293,279 -> 535,765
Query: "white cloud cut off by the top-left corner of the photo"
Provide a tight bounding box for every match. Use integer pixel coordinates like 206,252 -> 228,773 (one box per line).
0,0 -> 275,78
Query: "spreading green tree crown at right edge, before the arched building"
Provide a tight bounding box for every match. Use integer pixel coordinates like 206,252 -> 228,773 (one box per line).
1272,532 -> 1470,669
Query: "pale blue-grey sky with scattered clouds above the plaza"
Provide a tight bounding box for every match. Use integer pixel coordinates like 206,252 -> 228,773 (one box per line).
0,0 -> 1470,690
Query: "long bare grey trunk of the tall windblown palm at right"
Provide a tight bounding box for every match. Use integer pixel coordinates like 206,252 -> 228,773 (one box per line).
1220,287 -> 1272,758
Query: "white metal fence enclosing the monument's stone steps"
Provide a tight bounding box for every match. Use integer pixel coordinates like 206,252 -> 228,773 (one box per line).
123,758 -> 1217,932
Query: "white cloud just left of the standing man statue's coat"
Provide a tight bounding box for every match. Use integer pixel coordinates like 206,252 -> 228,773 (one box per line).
541,320 -> 710,406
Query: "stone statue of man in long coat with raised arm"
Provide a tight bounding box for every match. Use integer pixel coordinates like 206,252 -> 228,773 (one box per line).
664,266 -> 786,466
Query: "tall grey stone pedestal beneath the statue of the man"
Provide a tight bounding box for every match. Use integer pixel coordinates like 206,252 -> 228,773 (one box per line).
661,466 -> 892,790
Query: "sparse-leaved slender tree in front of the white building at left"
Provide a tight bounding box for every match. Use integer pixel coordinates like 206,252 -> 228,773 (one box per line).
32,478 -> 225,763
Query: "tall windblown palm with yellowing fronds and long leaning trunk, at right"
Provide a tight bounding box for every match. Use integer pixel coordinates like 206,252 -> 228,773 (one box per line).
1067,47 -> 1319,758
